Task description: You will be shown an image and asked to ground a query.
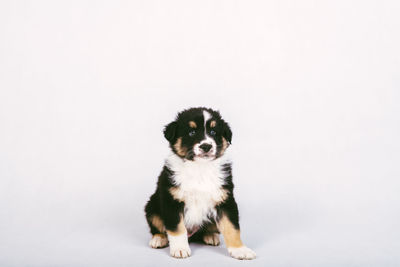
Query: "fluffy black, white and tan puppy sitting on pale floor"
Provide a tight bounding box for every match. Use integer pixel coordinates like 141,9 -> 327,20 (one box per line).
145,108 -> 256,259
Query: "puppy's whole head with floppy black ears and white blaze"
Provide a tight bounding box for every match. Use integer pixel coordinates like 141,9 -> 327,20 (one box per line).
164,108 -> 232,160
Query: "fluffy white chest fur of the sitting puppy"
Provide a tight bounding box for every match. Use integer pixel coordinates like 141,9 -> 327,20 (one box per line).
166,155 -> 229,229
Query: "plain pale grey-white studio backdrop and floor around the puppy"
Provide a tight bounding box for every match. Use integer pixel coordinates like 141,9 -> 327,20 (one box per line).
0,0 -> 400,267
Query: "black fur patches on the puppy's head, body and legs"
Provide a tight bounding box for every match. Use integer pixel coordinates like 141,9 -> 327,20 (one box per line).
145,108 -> 239,241
